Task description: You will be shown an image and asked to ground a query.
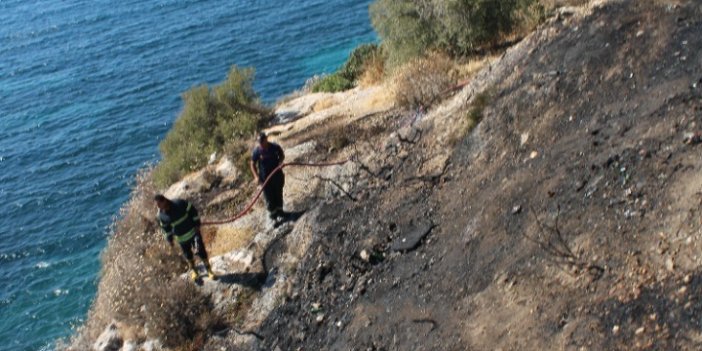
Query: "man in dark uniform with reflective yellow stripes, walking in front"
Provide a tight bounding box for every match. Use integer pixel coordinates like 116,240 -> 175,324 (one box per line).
154,194 -> 217,281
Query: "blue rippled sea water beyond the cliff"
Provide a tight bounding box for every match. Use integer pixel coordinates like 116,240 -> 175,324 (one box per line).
0,0 -> 376,350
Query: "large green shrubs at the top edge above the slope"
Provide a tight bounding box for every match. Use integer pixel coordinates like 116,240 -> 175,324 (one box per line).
370,0 -> 538,67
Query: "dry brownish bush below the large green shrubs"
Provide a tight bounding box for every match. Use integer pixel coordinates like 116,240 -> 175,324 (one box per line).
395,53 -> 455,109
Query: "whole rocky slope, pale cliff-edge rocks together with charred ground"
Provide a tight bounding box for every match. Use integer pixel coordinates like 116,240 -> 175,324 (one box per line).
84,0 -> 702,350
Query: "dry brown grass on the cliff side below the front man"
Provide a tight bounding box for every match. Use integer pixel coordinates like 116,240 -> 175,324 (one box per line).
67,169 -> 220,350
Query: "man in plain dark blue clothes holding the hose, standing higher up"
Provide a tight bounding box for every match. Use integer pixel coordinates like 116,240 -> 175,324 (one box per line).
249,132 -> 285,220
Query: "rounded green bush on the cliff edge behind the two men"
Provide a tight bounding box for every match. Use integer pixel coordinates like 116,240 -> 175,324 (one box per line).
154,66 -> 268,187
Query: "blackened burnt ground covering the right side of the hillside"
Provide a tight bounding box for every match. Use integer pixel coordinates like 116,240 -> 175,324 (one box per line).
252,1 -> 702,350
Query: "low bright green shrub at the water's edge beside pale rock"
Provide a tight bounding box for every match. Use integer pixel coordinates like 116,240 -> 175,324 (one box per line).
312,44 -> 382,93
